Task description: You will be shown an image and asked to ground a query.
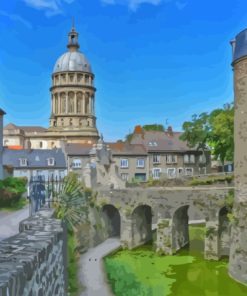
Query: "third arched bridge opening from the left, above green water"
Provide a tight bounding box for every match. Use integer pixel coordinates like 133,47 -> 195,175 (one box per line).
172,205 -> 189,251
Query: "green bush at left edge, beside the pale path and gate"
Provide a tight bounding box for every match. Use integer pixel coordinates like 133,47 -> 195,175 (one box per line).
0,177 -> 27,207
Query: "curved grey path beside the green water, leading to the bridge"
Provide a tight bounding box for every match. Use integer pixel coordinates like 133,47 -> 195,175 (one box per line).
79,238 -> 120,296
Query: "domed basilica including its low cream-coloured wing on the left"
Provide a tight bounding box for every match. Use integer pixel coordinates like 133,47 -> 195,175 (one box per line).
4,27 -> 99,149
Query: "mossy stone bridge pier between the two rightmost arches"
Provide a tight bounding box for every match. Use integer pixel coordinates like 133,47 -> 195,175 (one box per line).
204,221 -> 220,260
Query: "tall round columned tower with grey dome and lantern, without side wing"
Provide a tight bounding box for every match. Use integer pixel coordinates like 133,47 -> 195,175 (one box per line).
49,24 -> 99,143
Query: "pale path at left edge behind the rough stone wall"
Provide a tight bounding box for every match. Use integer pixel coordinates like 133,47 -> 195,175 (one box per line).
0,206 -> 29,240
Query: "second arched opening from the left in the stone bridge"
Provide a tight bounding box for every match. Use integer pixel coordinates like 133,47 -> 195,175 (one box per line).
132,205 -> 152,247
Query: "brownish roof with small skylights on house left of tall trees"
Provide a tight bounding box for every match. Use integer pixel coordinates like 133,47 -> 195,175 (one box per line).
130,131 -> 196,152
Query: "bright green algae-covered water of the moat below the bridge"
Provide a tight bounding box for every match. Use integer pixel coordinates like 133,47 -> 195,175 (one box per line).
105,226 -> 247,296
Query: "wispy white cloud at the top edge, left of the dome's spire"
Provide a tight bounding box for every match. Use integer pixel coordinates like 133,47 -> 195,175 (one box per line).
23,0 -> 74,16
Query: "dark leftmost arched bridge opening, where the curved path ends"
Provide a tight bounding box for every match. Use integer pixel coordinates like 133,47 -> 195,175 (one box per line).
102,205 -> 121,237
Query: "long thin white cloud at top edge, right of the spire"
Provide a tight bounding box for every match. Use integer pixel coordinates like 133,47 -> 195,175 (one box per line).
101,0 -> 187,11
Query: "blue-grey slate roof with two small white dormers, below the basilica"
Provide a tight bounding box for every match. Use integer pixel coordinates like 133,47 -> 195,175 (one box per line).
3,148 -> 67,169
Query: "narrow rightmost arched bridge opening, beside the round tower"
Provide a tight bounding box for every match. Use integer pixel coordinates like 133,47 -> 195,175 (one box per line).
219,207 -> 231,257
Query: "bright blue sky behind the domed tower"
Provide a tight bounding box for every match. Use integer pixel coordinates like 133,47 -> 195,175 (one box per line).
0,0 -> 247,141
